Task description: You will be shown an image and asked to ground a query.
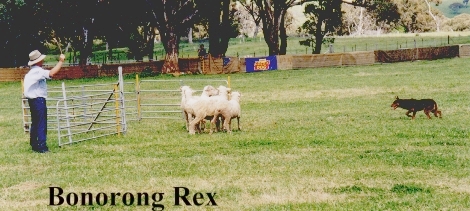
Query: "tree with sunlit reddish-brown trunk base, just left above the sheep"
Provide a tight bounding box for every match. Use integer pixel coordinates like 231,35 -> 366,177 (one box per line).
146,0 -> 197,73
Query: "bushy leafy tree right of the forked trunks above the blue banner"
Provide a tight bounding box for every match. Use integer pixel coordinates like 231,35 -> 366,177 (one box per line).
301,0 -> 342,54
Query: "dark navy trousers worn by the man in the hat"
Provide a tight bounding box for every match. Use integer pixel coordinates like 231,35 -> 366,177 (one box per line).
28,97 -> 49,152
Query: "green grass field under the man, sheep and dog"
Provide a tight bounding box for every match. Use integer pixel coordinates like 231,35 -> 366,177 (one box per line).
0,58 -> 470,211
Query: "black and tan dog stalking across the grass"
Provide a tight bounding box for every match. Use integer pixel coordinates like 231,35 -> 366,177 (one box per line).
391,96 -> 442,119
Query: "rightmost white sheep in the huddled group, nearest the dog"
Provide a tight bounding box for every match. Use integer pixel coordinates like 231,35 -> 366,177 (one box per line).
212,92 -> 241,133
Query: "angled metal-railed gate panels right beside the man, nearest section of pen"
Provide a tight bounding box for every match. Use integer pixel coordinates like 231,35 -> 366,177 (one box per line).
22,67 -> 133,146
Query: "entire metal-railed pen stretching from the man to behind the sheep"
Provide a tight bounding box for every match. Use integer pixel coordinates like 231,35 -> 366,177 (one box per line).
22,67 -> 230,146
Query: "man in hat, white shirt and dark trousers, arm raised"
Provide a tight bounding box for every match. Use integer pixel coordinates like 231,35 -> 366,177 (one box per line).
24,50 -> 65,153
